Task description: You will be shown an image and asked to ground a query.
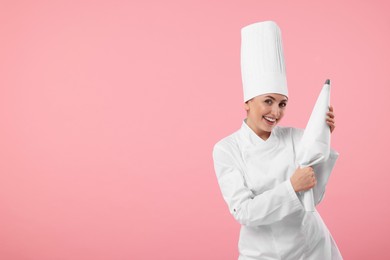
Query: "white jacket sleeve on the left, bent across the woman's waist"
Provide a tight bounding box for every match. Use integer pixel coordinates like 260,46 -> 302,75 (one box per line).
213,144 -> 303,226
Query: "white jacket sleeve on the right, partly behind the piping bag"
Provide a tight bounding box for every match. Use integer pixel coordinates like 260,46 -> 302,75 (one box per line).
313,149 -> 339,205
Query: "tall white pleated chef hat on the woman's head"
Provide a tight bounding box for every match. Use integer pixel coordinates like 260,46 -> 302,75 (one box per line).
241,21 -> 288,102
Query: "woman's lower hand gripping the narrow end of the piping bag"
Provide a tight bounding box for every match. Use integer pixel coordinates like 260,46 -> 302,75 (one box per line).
290,167 -> 317,192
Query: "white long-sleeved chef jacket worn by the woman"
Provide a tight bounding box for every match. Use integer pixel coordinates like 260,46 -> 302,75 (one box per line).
213,121 -> 342,260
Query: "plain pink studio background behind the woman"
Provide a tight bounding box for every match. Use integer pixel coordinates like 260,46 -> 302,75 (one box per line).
0,0 -> 390,260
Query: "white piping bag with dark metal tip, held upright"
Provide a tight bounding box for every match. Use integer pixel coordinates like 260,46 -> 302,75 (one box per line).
296,79 -> 330,211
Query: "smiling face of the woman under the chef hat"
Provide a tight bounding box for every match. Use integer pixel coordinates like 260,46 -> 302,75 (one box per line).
244,94 -> 288,140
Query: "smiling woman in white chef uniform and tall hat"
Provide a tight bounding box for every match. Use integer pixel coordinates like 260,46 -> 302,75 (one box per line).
213,21 -> 342,260
